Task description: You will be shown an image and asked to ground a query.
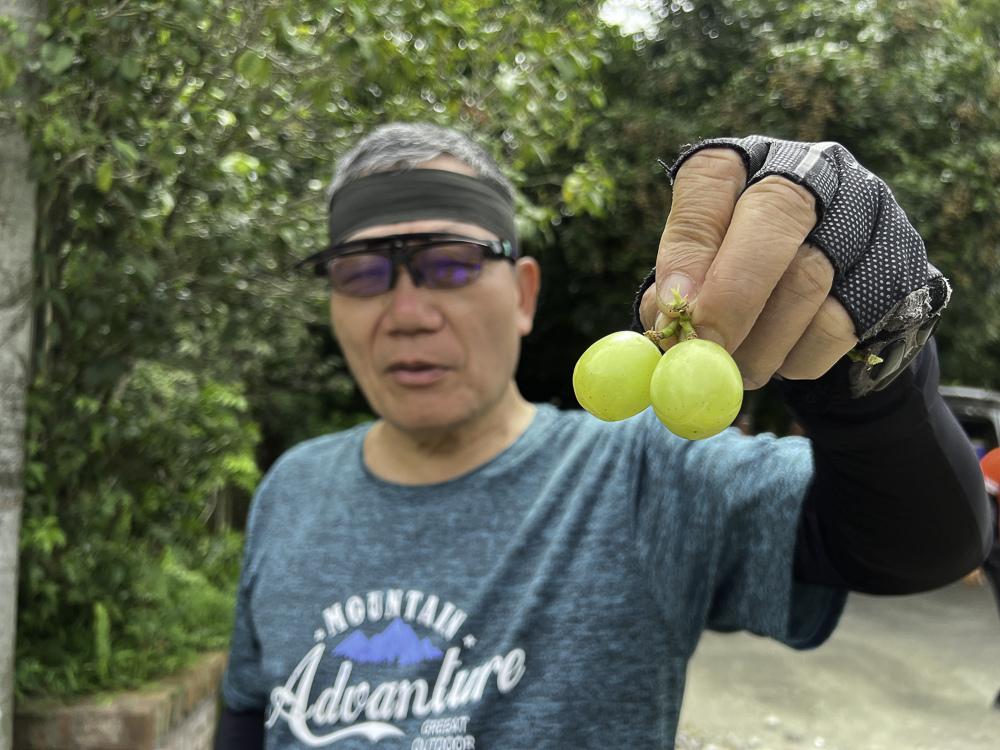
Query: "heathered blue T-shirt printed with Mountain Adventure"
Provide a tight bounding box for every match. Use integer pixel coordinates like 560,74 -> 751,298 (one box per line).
223,405 -> 846,750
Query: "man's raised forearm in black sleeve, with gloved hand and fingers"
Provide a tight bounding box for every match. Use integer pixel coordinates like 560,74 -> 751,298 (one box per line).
635,136 -> 988,593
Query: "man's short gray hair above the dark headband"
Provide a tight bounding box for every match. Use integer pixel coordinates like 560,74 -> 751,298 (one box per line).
327,122 -> 514,203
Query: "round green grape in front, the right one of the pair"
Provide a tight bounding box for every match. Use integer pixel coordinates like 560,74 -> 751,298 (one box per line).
649,339 -> 743,440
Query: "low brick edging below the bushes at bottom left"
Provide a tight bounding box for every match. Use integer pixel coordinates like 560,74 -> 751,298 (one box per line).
13,652 -> 226,750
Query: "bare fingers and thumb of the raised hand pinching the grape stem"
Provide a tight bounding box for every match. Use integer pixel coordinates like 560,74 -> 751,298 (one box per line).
640,148 -> 857,390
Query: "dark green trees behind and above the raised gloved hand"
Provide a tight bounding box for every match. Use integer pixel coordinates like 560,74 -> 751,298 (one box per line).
525,0 -> 1000,412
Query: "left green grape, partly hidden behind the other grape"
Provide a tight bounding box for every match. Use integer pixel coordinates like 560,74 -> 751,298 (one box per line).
573,331 -> 661,422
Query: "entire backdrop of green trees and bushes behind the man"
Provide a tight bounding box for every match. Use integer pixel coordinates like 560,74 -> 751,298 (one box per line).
0,0 -> 1000,697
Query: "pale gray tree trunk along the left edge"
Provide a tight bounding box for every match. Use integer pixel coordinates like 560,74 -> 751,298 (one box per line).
0,0 -> 44,750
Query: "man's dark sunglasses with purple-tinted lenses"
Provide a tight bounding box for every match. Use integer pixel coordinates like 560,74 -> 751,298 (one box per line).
298,234 -> 517,297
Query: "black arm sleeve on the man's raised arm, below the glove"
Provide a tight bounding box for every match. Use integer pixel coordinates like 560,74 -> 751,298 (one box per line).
778,339 -> 991,594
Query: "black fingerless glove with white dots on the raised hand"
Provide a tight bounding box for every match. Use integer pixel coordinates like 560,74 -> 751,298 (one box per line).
640,136 -> 951,397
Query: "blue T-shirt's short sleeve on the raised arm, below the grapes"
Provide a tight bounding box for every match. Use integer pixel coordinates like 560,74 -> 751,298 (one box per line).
636,415 -> 847,650
